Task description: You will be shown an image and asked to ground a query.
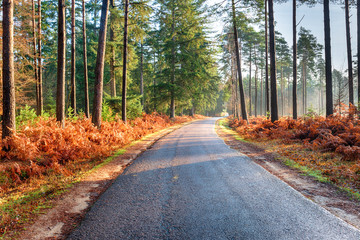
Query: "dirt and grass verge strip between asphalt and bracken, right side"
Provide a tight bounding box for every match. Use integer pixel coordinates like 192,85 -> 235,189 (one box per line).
216,119 -> 360,229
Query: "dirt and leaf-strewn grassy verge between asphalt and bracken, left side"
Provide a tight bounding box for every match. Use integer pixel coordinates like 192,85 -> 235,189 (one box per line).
0,115 -> 200,240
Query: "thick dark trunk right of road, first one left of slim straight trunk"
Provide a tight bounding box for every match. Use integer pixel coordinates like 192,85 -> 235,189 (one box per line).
268,0 -> 279,122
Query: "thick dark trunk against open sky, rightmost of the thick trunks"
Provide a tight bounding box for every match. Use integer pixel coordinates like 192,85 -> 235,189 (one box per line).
324,0 -> 334,116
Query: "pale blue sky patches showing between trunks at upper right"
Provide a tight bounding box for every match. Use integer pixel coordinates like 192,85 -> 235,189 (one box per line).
208,0 -> 357,71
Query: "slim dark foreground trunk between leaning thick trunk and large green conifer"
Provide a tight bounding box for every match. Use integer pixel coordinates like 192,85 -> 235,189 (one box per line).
121,0 -> 129,123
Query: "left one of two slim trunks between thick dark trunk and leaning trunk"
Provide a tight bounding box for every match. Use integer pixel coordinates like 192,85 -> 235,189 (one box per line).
70,0 -> 76,114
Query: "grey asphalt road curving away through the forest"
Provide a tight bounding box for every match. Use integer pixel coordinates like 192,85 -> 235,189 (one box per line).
69,119 -> 360,240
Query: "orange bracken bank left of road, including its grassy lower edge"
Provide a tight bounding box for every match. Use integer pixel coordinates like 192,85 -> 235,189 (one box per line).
0,108 -> 201,239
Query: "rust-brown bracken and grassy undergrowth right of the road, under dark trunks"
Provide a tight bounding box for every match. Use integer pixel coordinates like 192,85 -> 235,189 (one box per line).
223,108 -> 360,199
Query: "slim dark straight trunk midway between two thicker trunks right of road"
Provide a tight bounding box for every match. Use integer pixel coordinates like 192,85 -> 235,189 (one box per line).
292,0 -> 297,119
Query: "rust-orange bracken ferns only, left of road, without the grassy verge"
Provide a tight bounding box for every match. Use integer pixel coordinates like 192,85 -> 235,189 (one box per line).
0,113 -> 199,192
